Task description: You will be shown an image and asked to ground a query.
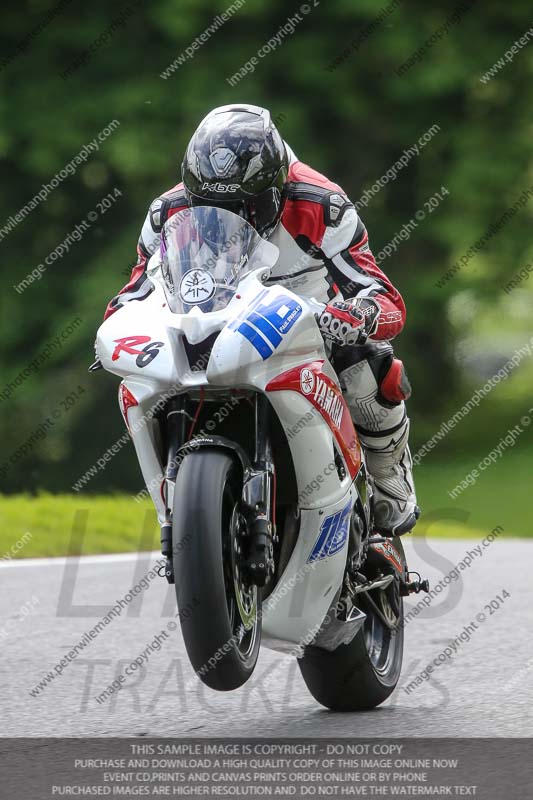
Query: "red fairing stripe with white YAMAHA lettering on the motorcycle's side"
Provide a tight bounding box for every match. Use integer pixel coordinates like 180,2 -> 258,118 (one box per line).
266,361 -> 361,478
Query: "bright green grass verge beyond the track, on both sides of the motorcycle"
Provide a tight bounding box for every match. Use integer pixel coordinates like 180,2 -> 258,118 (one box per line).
0,448 -> 533,558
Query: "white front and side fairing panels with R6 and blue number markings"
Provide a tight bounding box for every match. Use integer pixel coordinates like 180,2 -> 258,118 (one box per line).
97,217 -> 364,651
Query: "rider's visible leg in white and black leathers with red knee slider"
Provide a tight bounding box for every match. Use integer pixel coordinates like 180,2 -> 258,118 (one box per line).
332,342 -> 419,536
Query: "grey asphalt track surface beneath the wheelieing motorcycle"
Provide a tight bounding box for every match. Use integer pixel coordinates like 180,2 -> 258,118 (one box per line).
0,536 -> 533,737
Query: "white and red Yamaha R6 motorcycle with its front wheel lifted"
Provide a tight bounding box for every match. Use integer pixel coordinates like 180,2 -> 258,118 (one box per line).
97,207 -> 426,710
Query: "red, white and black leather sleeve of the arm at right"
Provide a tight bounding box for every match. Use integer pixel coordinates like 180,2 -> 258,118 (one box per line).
321,203 -> 405,340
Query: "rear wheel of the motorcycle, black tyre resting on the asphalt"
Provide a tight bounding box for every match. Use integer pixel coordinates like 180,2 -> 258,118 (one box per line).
298,538 -> 405,711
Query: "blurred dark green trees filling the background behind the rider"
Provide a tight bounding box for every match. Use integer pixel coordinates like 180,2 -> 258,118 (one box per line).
0,0 -> 533,533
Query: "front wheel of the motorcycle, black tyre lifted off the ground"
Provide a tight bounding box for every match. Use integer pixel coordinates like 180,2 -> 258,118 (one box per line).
172,448 -> 261,691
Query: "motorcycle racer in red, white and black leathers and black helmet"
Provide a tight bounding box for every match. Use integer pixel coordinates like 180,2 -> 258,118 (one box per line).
105,104 -> 419,536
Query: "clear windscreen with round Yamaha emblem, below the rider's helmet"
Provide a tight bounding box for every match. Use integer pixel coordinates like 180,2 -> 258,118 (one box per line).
161,206 -> 278,314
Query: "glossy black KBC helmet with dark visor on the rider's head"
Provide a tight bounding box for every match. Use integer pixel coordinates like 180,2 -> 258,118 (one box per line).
182,105 -> 289,235
